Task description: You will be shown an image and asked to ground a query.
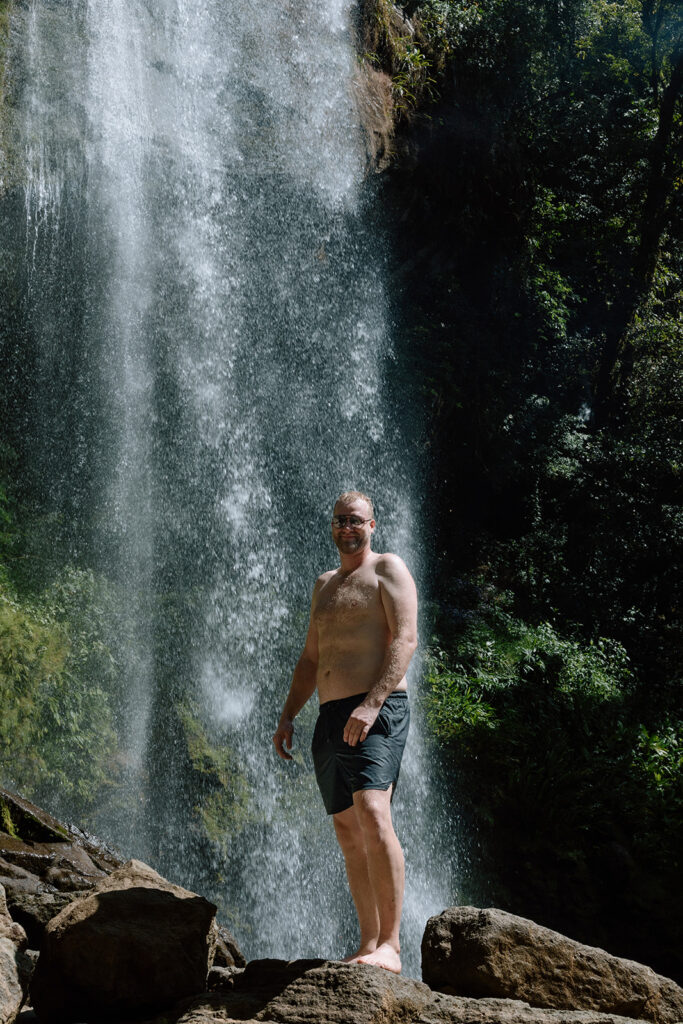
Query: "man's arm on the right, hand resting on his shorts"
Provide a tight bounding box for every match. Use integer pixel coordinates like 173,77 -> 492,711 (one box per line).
344,555 -> 418,746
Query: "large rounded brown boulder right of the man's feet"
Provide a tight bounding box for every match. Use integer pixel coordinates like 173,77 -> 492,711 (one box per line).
422,906 -> 683,1024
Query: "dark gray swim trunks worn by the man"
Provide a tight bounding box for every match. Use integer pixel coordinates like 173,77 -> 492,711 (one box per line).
311,692 -> 411,814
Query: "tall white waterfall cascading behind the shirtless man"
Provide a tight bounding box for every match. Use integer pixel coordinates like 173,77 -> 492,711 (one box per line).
5,0 -> 453,975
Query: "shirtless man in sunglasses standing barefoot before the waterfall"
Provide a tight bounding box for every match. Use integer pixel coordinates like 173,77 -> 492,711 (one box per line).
272,490 -> 418,974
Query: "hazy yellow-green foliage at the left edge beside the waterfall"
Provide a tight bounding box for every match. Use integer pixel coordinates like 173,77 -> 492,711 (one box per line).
0,468 -> 119,823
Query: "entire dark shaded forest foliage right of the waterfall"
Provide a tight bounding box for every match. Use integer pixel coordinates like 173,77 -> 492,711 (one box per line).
390,0 -> 683,973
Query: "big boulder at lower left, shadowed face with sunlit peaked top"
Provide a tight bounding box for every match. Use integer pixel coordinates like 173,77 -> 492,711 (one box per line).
31,860 -> 216,1024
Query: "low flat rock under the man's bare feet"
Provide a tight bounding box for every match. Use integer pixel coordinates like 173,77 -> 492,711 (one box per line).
150,959 -> 655,1024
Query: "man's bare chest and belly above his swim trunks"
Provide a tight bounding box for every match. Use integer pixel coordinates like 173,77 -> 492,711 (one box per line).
313,555 -> 407,703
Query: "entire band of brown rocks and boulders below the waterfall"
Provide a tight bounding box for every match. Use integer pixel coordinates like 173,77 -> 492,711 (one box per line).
0,791 -> 683,1024
